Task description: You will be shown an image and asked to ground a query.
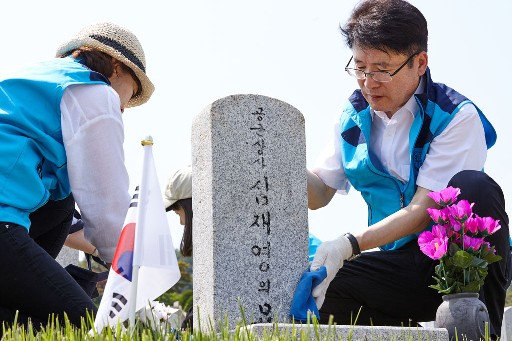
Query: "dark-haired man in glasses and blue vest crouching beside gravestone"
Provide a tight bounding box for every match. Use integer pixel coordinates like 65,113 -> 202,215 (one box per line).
308,0 -> 510,335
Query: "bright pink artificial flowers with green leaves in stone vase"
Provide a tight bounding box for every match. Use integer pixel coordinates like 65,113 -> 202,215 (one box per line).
418,187 -> 501,295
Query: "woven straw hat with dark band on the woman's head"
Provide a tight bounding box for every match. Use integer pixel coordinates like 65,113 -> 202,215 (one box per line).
56,22 -> 155,107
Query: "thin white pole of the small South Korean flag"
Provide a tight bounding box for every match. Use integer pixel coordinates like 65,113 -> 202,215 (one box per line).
128,136 -> 153,328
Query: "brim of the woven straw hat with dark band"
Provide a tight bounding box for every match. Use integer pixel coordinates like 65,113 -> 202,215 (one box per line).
56,37 -> 155,108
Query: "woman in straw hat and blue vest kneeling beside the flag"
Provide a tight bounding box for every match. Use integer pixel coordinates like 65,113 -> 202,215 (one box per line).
0,23 -> 154,327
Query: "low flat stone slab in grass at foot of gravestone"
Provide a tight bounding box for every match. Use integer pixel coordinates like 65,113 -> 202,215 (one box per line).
241,323 -> 448,341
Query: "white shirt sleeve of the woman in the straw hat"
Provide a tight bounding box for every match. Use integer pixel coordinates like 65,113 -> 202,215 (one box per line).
60,84 -> 131,262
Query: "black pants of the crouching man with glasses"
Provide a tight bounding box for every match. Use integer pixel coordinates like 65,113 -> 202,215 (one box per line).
320,171 -> 512,336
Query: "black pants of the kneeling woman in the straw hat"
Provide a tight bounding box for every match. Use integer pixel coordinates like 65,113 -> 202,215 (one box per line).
0,195 -> 96,328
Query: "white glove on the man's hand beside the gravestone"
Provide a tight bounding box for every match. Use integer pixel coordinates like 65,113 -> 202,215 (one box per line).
310,236 -> 352,309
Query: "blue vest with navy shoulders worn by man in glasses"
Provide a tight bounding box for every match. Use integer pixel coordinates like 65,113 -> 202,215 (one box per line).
340,68 -> 496,250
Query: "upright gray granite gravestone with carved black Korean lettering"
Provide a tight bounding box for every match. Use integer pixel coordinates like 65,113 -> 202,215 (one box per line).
192,95 -> 308,328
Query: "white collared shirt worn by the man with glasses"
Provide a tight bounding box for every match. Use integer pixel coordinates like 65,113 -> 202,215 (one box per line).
312,79 -> 487,194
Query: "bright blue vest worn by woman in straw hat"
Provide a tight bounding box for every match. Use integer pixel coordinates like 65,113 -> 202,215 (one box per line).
0,57 -> 110,229
